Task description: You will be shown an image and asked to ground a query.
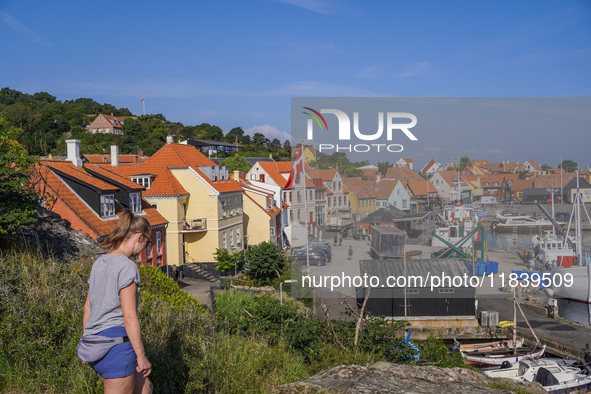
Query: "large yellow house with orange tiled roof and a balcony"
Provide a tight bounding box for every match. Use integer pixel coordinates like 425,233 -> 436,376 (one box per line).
117,142 -> 244,266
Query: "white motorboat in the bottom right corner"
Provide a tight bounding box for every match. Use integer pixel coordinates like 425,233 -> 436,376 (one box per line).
484,358 -> 591,394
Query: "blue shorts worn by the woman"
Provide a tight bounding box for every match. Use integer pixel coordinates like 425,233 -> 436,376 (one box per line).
88,326 -> 137,379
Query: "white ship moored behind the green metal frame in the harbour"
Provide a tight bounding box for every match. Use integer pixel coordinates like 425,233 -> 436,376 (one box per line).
431,201 -> 480,250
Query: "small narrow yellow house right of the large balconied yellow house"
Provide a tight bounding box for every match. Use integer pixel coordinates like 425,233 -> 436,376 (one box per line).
241,181 -> 287,245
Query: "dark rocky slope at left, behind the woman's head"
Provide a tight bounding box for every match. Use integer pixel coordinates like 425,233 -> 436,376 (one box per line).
0,209 -> 105,260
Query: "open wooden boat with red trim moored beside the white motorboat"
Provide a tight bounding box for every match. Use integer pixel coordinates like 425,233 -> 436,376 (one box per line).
462,345 -> 546,367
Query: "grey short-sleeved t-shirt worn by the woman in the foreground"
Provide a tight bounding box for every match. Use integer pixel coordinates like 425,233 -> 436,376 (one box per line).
84,254 -> 140,334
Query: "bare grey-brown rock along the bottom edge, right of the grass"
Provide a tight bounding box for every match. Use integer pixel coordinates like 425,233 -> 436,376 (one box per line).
274,362 -> 546,394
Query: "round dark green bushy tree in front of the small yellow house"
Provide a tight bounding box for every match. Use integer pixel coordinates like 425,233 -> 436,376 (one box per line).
246,242 -> 285,285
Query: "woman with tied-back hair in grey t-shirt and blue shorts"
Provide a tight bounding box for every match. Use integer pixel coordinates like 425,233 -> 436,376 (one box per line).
84,209 -> 152,394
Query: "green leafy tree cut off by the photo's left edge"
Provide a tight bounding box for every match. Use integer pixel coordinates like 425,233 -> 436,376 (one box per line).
0,118 -> 39,234
